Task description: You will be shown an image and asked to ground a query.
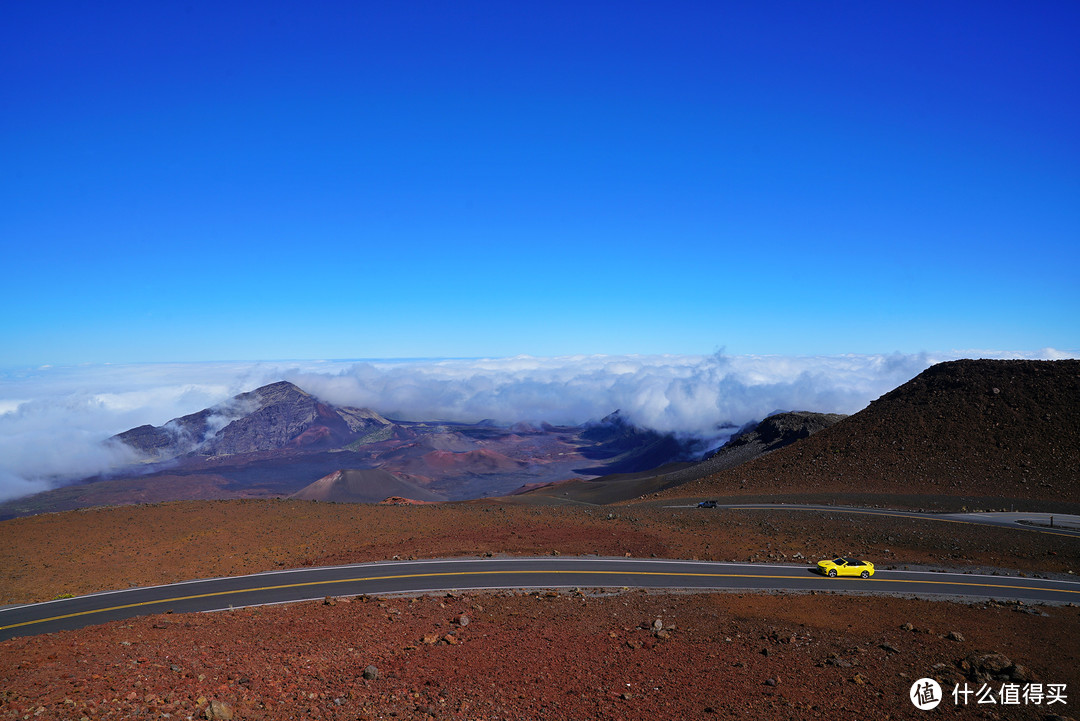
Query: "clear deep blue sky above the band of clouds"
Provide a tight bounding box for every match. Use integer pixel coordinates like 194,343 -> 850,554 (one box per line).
0,0 -> 1080,366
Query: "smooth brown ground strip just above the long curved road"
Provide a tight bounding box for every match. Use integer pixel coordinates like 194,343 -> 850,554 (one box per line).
0,500 -> 1080,603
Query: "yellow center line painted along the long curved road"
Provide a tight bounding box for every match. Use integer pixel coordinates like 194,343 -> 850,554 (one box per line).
0,570 -> 1080,630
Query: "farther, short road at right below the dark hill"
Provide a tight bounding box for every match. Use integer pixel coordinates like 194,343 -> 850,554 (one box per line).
664,503 -> 1080,539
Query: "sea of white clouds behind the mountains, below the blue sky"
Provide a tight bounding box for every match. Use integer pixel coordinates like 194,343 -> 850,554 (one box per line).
0,349 -> 1077,500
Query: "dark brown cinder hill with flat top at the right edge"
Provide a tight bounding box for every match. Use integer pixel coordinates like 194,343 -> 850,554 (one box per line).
666,361 -> 1080,502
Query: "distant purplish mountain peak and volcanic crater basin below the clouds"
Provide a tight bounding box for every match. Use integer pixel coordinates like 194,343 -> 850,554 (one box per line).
0,381 -> 708,518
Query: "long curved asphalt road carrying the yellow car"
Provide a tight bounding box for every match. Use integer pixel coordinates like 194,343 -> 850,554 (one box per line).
0,557 -> 1080,640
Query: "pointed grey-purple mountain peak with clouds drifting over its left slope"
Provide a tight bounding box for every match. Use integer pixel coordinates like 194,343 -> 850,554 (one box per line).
113,381 -> 391,459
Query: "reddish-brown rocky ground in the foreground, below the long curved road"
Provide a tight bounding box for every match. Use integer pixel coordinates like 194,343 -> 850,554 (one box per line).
0,591 -> 1080,721
